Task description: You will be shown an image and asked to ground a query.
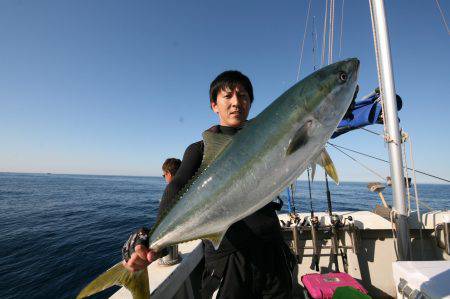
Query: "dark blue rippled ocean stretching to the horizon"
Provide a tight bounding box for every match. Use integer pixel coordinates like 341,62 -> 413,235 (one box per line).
0,173 -> 450,299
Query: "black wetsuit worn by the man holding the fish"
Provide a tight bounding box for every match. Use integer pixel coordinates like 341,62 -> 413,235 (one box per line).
158,126 -> 292,298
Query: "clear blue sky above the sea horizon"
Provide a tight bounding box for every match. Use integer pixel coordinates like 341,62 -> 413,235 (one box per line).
0,0 -> 450,182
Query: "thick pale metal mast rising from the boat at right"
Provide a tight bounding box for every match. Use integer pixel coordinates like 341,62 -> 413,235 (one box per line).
369,0 -> 411,260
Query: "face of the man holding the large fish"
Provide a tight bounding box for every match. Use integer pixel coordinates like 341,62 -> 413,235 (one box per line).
211,85 -> 251,127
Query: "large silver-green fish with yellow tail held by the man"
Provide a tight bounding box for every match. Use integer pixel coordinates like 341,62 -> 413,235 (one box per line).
78,59 -> 359,298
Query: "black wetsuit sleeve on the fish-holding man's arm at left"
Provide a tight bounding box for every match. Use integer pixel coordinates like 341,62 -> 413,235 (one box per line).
157,141 -> 203,221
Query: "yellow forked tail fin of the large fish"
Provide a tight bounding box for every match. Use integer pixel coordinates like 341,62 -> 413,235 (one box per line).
77,262 -> 150,299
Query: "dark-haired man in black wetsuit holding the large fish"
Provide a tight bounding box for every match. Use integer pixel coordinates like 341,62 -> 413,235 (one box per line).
124,71 -> 292,298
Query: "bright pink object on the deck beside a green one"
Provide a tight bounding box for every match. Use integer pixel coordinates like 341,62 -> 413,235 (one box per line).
302,272 -> 367,299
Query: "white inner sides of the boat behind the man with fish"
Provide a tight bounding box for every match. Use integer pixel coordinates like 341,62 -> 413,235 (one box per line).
111,211 -> 450,299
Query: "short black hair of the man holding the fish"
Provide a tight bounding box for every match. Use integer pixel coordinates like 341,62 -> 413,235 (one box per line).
209,71 -> 253,104
